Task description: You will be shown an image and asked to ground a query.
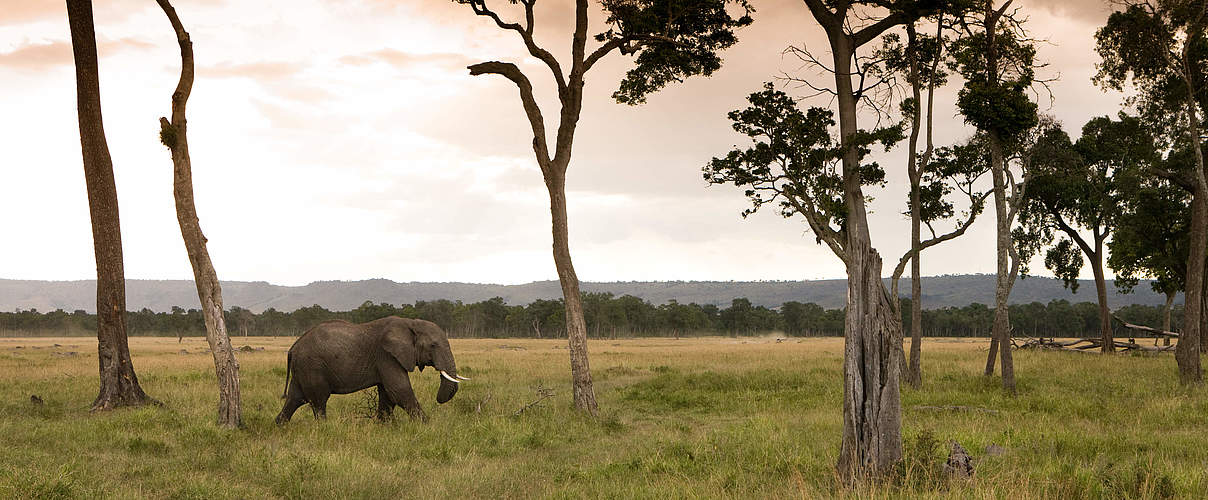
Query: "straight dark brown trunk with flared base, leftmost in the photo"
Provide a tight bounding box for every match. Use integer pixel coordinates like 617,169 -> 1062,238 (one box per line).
68,0 -> 156,411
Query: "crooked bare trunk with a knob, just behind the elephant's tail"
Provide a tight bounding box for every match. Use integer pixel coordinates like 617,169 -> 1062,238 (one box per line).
156,0 -> 242,429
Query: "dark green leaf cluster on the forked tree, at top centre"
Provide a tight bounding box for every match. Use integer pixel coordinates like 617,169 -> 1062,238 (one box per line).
596,0 -> 755,105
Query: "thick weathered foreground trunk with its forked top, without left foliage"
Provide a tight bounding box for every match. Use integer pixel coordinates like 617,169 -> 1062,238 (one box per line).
787,0 -> 966,481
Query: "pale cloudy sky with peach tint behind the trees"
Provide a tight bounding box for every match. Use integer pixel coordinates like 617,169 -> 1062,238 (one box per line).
0,0 -> 1123,285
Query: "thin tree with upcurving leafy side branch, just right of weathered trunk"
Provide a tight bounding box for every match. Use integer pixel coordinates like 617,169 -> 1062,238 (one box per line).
878,13 -> 989,389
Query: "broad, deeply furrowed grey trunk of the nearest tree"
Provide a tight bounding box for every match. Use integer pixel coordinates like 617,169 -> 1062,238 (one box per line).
830,35 -> 902,482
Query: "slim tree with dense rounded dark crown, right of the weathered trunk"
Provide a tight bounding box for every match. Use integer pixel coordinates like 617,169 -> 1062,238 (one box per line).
953,0 -> 1038,394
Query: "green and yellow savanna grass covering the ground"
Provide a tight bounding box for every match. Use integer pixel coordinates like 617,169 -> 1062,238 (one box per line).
0,337 -> 1208,499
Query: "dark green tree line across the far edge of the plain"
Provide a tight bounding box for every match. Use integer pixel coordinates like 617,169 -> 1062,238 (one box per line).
0,292 -> 1183,338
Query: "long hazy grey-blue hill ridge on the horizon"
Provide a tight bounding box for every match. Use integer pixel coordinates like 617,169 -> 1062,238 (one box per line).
0,274 -> 1165,313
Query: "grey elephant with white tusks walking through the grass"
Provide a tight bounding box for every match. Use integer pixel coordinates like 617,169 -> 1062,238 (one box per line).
277,316 -> 469,425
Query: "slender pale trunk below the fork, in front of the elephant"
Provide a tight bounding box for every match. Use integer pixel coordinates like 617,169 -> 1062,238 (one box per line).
546,170 -> 598,417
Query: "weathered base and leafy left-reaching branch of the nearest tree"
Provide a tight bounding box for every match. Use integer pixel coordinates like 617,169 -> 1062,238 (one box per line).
704,76 -> 901,479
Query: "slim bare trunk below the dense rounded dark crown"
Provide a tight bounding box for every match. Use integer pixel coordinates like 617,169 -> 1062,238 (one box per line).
986,132 -> 1015,394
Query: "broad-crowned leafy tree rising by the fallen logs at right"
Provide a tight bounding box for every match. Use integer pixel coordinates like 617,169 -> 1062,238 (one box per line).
1017,116 -> 1157,353
